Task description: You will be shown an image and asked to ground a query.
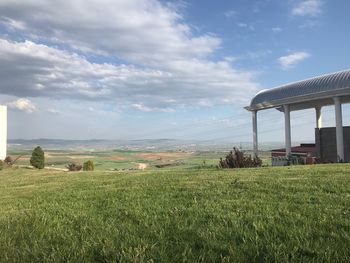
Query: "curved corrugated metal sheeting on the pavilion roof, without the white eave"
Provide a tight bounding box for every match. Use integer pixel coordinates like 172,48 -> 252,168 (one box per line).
249,70 -> 350,109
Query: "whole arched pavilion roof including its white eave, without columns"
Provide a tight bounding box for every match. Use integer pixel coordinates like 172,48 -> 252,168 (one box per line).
245,70 -> 350,111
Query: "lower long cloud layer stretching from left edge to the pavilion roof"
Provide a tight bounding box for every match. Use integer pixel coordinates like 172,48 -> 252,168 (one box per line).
0,39 -> 257,110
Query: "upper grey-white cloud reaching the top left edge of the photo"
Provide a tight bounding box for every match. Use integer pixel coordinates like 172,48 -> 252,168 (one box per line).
0,0 -> 221,65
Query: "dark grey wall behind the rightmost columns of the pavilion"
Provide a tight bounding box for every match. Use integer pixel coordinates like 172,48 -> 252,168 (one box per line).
315,127 -> 350,162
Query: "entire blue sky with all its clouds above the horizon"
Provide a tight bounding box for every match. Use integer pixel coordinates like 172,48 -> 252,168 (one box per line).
0,0 -> 350,142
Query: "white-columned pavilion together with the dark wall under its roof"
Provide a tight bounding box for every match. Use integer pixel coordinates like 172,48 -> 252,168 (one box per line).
245,70 -> 350,162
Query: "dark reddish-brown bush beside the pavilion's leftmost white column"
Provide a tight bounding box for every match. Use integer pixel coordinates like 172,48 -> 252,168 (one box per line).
219,147 -> 262,168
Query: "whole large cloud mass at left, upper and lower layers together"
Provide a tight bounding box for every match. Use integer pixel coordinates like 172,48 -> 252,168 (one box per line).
0,0 -> 257,112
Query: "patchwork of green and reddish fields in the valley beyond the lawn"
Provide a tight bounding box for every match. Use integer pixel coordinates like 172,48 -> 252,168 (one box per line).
9,147 -> 270,171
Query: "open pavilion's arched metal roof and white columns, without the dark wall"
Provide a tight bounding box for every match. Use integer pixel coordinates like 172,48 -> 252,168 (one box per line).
245,70 -> 350,161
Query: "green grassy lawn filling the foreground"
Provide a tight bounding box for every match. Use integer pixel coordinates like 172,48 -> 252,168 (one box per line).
0,164 -> 350,262
